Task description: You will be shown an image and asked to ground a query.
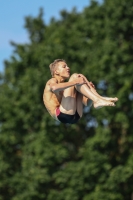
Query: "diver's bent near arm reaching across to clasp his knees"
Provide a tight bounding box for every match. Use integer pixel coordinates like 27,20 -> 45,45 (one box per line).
49,78 -> 86,92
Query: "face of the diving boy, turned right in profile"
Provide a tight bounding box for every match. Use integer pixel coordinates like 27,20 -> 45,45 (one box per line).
56,62 -> 70,79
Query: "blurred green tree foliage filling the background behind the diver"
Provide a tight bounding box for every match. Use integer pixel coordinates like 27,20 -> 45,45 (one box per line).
0,0 -> 133,200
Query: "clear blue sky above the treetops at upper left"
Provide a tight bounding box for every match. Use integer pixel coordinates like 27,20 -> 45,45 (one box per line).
0,0 -> 96,72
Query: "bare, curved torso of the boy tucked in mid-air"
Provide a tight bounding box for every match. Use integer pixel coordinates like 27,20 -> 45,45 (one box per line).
43,78 -> 63,120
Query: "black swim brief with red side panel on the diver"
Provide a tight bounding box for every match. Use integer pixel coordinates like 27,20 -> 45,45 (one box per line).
56,108 -> 80,124
